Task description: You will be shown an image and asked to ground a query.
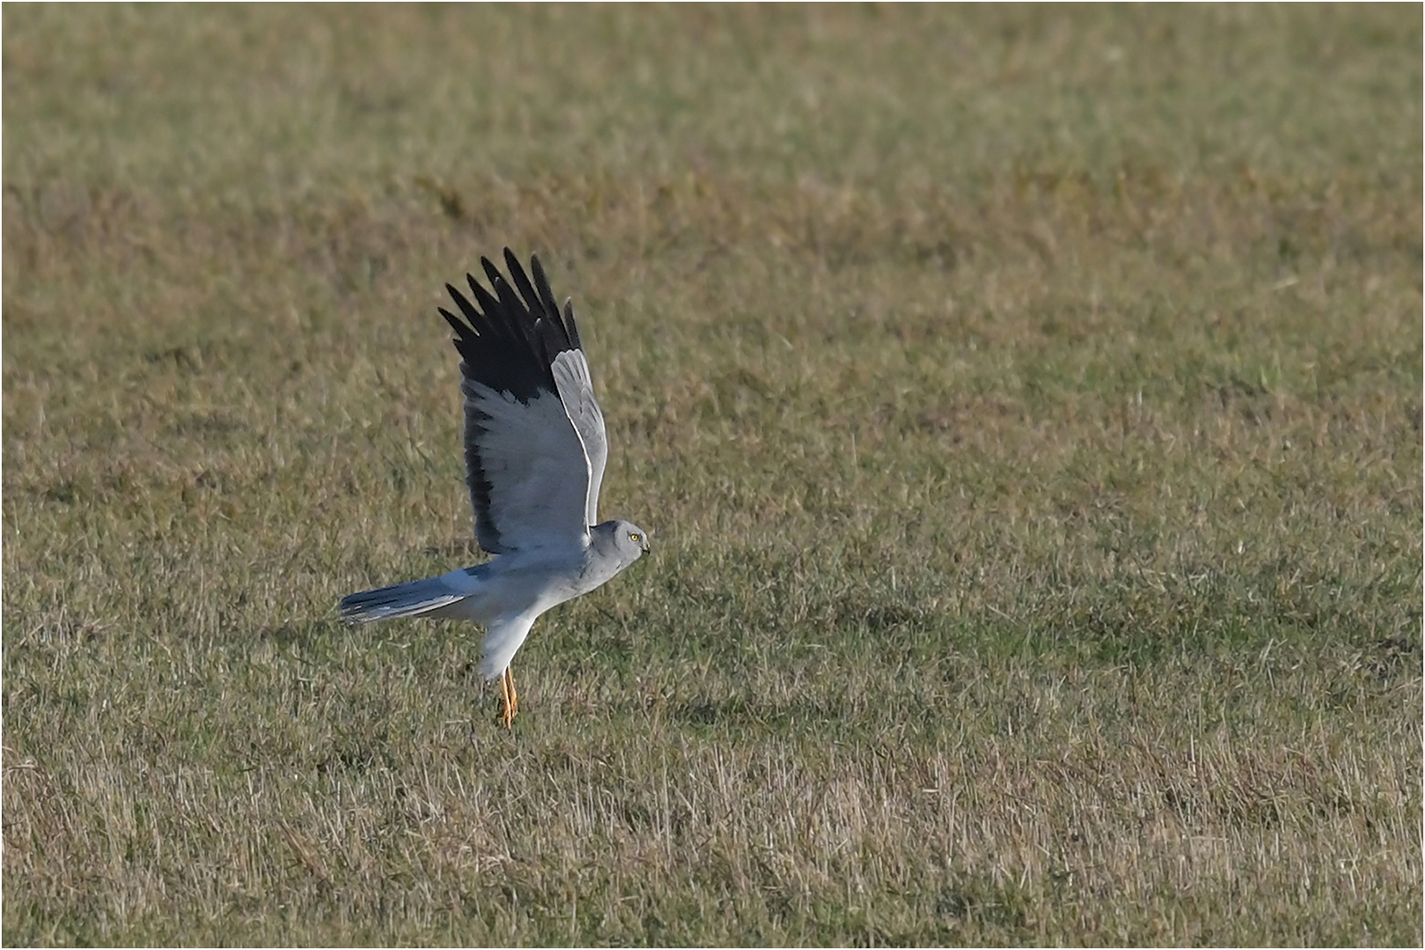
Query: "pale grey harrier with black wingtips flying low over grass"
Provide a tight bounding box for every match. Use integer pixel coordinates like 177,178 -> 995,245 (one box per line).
341,248 -> 648,728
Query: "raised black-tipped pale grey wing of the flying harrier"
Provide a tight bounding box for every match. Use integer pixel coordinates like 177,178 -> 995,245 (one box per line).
440,248 -> 608,554
